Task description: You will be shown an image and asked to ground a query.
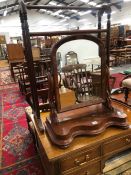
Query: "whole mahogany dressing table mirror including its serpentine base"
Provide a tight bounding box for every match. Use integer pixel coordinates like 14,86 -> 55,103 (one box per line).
45,34 -> 128,148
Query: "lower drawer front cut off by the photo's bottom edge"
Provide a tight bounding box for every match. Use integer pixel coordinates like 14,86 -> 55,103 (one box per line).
63,161 -> 101,175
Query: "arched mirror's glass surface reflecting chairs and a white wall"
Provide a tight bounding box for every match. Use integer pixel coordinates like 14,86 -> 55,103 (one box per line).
56,39 -> 102,108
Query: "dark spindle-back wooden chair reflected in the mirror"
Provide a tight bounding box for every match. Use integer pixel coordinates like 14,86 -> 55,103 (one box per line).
62,64 -> 101,103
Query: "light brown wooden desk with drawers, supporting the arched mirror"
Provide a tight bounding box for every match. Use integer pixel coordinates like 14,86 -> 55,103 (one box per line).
26,102 -> 131,175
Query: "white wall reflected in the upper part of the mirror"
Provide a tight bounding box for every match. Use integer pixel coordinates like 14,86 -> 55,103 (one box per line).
57,39 -> 100,66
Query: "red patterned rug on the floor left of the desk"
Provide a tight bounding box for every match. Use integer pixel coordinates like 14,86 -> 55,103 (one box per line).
0,84 -> 44,175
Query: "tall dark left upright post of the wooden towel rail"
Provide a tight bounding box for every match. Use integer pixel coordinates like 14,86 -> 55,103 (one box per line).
19,0 -> 44,132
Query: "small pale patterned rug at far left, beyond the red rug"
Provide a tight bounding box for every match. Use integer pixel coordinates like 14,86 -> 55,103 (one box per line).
0,67 -> 14,86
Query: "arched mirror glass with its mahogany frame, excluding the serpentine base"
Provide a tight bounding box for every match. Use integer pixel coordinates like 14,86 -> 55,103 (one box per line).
52,35 -> 106,112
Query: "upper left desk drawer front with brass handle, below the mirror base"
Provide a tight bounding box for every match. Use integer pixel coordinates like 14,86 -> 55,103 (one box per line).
61,146 -> 101,172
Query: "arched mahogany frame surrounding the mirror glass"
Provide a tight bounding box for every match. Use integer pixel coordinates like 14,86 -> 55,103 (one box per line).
51,34 -> 109,113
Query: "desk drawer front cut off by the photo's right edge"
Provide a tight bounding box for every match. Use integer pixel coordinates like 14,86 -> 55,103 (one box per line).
103,134 -> 131,155
